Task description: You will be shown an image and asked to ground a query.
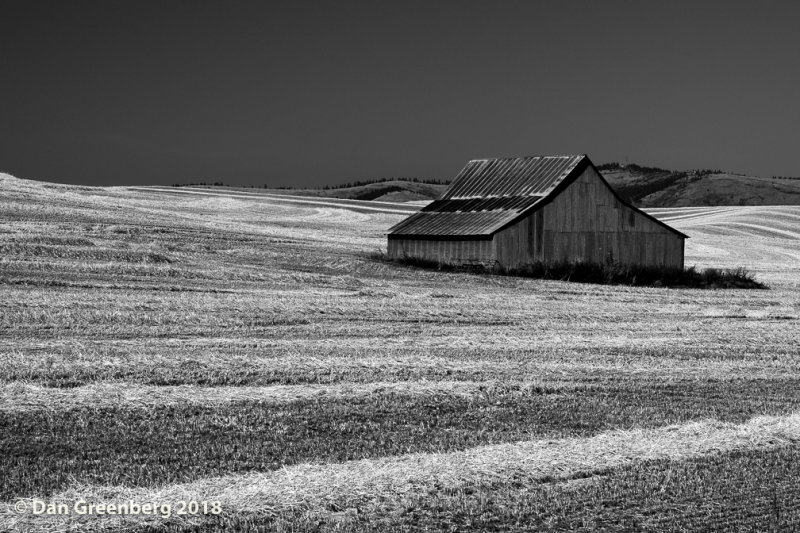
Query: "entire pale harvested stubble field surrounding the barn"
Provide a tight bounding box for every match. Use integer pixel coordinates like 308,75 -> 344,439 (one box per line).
0,175 -> 800,532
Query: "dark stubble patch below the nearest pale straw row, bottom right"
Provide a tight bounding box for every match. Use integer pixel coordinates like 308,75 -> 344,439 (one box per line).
308,446 -> 800,533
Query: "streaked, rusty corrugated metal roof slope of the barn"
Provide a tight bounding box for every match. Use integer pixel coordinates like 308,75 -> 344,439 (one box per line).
389,155 -> 585,237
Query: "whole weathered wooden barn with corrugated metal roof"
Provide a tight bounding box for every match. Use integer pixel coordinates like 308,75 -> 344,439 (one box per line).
388,155 -> 687,269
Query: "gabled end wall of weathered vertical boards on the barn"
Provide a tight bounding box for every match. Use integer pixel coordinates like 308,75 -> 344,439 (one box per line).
493,167 -> 684,268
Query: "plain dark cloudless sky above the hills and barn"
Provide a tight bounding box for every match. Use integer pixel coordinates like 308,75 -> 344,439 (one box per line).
0,0 -> 800,186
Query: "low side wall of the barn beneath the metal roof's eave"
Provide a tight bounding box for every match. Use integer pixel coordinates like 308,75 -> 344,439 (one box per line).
388,239 -> 493,265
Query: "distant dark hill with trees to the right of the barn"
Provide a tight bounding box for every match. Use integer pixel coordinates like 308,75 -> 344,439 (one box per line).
598,163 -> 800,207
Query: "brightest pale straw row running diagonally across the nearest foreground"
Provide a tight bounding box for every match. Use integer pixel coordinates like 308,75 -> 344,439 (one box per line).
0,415 -> 800,530
